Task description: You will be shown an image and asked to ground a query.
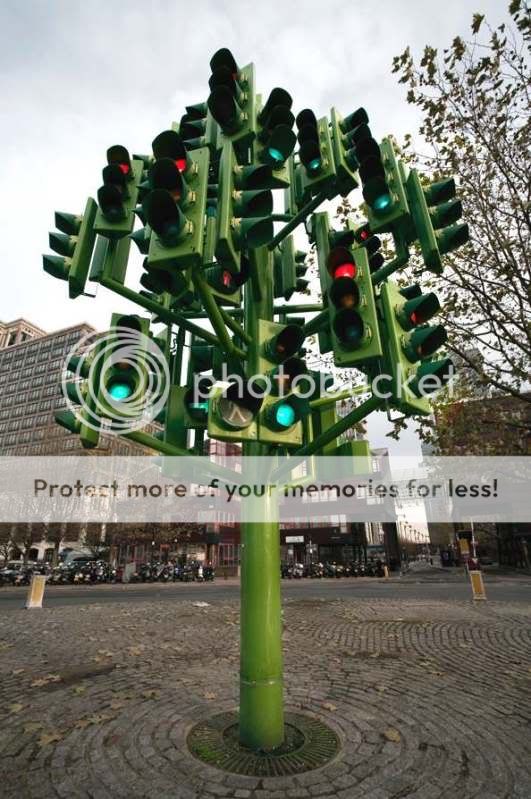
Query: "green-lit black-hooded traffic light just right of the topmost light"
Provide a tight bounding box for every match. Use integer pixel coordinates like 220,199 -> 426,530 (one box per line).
257,87 -> 297,169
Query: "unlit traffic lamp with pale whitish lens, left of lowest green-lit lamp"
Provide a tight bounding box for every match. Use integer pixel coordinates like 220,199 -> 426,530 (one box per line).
208,378 -> 264,441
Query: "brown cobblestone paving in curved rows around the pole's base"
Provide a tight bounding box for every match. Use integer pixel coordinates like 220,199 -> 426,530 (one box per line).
0,598 -> 531,799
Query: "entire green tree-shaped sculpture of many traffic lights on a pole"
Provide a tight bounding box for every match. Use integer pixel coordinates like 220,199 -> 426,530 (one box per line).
44,48 -> 468,751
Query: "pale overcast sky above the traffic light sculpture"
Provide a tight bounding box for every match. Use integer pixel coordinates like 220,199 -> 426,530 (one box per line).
0,0 -> 507,456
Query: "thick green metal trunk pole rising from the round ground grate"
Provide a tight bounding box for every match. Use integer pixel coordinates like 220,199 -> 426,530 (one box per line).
240,247 -> 284,751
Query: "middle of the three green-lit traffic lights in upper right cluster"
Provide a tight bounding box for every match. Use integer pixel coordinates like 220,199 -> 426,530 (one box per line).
295,108 -> 335,202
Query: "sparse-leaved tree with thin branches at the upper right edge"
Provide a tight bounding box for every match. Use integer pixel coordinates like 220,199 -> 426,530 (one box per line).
393,0 -> 531,404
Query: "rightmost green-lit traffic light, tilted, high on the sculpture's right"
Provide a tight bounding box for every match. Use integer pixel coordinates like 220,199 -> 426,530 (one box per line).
350,117 -> 409,233
